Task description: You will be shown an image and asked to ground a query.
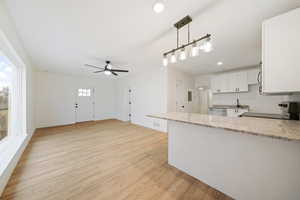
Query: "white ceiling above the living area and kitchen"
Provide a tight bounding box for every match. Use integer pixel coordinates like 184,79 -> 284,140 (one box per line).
6,0 -> 300,75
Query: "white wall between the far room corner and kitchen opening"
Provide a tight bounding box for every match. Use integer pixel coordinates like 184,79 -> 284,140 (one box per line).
116,68 -> 167,132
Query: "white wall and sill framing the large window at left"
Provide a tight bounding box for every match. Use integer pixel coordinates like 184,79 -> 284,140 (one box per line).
0,1 -> 35,196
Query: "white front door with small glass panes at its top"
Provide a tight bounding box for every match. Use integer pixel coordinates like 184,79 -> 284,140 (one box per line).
75,88 -> 94,122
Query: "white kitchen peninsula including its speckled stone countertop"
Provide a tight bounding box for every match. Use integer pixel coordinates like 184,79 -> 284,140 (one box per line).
149,113 -> 300,200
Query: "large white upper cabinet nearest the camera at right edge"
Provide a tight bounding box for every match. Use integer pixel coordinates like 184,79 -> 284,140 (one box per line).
262,8 -> 300,93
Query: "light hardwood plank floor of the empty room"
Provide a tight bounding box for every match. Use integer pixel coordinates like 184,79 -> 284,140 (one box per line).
2,120 -> 231,200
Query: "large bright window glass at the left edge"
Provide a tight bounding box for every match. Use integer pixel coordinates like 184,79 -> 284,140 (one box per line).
0,56 -> 12,140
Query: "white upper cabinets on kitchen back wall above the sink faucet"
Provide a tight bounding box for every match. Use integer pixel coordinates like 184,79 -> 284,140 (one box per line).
211,71 -> 248,93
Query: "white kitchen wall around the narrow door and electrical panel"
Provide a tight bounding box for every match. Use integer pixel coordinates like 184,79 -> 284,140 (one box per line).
167,67 -> 195,112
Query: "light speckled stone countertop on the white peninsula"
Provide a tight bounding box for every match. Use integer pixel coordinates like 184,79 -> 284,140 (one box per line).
148,112 -> 300,141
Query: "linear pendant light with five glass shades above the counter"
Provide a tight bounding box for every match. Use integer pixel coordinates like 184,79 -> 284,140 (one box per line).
163,15 -> 213,66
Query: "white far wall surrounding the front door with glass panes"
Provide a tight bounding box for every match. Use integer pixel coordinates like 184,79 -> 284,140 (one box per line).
36,72 -> 116,127
